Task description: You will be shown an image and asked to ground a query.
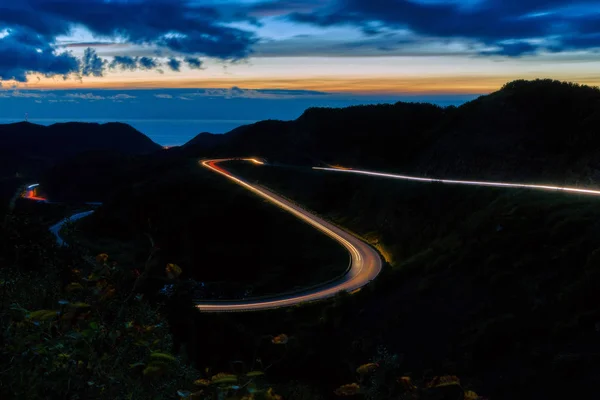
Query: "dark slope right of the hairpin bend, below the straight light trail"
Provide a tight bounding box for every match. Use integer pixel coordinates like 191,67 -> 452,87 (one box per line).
225,164 -> 600,398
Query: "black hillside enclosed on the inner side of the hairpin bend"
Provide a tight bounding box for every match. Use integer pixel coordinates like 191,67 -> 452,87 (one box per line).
62,160 -> 349,298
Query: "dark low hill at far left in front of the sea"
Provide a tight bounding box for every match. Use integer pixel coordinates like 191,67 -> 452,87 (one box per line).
0,122 -> 161,179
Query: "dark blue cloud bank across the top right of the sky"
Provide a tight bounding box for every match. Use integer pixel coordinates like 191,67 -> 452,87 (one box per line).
289,0 -> 600,55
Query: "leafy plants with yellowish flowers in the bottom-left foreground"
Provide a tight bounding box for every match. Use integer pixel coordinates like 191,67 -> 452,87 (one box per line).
0,254 -> 195,400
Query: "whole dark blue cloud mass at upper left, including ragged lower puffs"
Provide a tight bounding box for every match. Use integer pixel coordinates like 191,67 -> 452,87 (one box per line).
0,0 -> 256,81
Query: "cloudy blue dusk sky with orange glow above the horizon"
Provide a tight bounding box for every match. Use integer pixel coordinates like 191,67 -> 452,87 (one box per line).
0,0 -> 600,142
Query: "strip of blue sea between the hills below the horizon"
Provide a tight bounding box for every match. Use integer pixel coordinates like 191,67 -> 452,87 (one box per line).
0,118 -> 256,146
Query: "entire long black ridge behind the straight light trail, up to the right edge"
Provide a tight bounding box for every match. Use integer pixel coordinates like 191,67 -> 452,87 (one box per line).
184,80 -> 600,183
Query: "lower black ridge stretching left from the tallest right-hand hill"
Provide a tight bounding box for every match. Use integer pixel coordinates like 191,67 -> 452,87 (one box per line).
184,103 -> 446,167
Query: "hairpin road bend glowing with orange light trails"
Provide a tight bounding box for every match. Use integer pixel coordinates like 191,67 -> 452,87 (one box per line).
196,158 -> 382,312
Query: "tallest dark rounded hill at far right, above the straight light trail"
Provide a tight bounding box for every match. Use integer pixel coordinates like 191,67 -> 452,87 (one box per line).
413,80 -> 600,183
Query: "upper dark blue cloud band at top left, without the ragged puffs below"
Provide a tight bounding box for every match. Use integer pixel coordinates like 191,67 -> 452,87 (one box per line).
5,0 -> 256,59
